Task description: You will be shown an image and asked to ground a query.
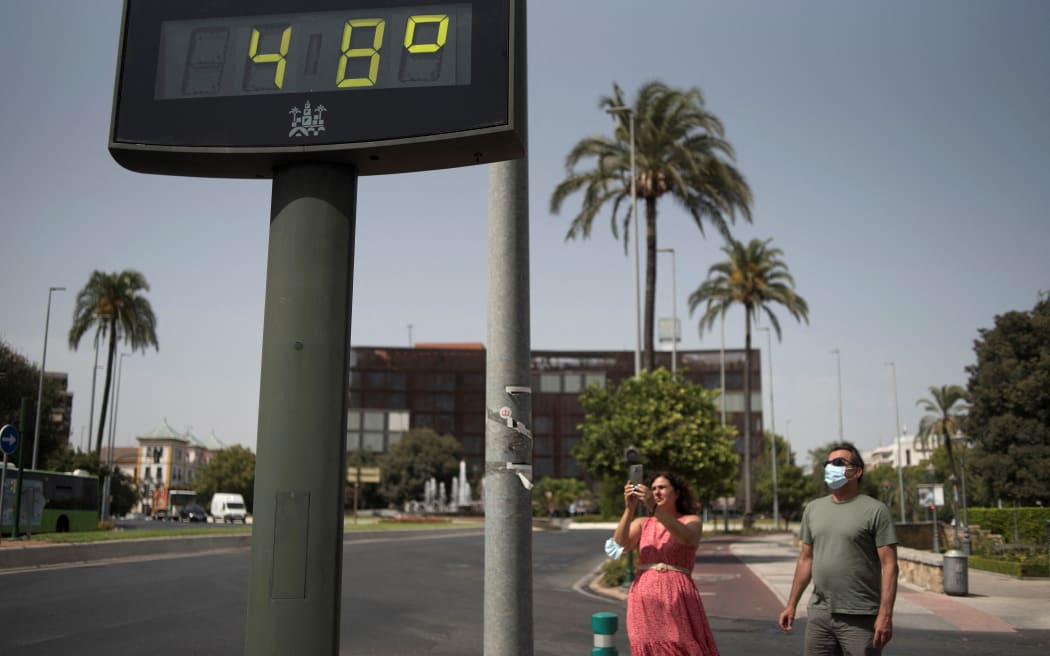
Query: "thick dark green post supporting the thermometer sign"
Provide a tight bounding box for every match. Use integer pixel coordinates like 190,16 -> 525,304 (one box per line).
245,164 -> 357,656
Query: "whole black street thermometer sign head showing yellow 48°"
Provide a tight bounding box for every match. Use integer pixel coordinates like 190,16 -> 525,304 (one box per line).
109,0 -> 525,177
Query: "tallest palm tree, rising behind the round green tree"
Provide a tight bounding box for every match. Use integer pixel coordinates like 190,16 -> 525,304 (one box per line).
550,81 -> 752,369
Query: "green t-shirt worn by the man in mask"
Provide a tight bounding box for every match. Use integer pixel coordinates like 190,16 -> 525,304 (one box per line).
799,494 -> 897,615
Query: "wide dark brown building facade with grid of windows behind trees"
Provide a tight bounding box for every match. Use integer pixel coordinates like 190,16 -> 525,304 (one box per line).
347,343 -> 762,479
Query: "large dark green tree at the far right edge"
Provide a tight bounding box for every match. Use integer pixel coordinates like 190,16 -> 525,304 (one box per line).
963,294 -> 1050,505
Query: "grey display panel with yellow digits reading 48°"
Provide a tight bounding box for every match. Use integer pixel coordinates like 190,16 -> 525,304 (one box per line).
154,4 -> 470,99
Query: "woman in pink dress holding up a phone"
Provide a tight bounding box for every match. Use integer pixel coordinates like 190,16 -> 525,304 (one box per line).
613,471 -> 718,656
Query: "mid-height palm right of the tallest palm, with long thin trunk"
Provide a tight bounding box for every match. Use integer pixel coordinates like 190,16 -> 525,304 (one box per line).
689,239 -> 810,526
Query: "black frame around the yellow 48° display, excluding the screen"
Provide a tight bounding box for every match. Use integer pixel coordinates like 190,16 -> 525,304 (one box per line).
109,0 -> 525,178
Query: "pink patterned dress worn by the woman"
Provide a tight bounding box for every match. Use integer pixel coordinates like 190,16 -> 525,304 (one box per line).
627,517 -> 718,656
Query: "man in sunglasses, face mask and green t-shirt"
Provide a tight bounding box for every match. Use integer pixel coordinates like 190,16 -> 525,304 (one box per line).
779,442 -> 897,656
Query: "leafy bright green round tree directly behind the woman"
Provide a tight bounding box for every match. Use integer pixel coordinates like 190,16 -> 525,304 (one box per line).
572,367 -> 737,505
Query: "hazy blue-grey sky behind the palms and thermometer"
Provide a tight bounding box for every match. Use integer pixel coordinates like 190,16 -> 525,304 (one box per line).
0,0 -> 1050,462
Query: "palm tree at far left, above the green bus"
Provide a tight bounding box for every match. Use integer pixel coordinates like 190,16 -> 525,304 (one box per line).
69,269 -> 160,458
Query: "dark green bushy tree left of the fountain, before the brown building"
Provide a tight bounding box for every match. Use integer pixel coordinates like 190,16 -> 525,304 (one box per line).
379,427 -> 463,506
